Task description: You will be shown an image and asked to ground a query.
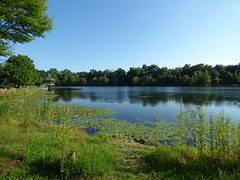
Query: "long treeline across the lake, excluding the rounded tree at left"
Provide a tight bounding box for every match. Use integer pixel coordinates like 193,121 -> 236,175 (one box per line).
37,64 -> 240,86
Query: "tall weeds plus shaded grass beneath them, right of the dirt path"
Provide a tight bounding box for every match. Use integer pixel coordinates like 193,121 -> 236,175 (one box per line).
145,104 -> 240,179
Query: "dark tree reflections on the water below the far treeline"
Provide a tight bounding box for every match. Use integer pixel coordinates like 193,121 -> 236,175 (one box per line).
54,87 -> 240,106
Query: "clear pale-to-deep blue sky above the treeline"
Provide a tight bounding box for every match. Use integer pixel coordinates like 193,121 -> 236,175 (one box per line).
15,0 -> 240,72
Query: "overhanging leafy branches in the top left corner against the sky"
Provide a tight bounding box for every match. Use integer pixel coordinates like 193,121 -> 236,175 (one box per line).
0,0 -> 53,56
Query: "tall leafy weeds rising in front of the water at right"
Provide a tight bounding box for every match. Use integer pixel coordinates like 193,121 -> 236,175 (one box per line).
175,105 -> 240,161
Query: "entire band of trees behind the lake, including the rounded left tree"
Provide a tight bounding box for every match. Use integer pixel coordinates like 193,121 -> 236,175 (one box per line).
0,59 -> 240,87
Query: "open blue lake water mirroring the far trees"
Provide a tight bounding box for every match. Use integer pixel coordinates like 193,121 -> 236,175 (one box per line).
55,86 -> 240,122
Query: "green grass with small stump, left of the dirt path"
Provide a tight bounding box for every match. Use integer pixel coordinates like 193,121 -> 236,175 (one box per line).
0,118 -> 116,179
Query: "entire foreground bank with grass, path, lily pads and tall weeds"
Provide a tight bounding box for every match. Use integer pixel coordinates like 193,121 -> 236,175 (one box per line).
0,87 -> 240,179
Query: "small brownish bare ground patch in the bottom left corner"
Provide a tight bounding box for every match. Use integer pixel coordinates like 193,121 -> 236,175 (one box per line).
0,159 -> 22,176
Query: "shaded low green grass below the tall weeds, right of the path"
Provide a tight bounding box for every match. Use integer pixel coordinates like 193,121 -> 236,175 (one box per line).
145,143 -> 240,179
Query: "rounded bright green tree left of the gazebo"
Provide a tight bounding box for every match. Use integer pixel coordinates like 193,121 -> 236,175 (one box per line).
3,55 -> 37,85
